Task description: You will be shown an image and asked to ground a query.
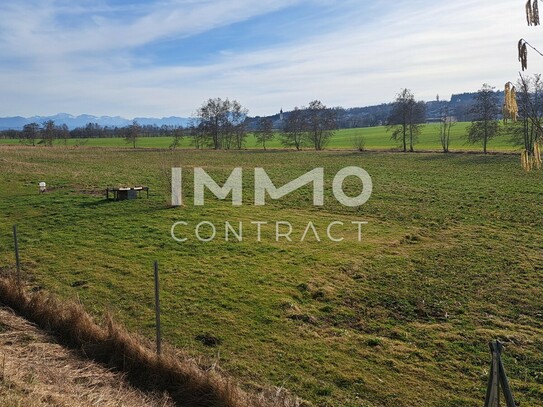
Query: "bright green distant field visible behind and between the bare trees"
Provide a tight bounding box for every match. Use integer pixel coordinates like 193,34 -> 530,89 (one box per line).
0,123 -> 518,151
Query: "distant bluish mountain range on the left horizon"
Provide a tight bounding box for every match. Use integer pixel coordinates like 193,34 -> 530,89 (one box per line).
0,113 -> 190,130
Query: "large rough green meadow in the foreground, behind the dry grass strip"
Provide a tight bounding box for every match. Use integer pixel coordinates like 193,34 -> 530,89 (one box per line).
0,145 -> 543,407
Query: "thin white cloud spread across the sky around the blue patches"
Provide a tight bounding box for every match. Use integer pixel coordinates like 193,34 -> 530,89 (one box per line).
0,0 -> 543,117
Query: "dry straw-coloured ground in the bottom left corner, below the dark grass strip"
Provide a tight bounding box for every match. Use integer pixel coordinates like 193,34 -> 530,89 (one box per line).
0,308 -> 174,407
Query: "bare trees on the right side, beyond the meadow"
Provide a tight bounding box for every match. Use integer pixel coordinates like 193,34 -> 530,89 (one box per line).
387,74 -> 543,163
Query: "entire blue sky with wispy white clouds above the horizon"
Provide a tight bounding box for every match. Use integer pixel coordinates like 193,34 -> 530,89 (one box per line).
0,0 -> 543,118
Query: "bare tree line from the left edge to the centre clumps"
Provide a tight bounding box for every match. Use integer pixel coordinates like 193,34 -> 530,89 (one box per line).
0,98 -> 338,150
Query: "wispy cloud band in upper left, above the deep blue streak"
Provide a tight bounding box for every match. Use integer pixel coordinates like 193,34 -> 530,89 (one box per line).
0,0 -> 306,58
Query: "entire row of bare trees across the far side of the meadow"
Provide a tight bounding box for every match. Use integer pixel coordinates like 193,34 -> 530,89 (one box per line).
2,80 -> 543,163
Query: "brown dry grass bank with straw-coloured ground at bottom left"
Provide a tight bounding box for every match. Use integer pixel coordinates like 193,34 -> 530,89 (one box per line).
0,278 -> 300,407
